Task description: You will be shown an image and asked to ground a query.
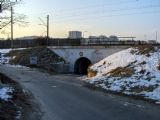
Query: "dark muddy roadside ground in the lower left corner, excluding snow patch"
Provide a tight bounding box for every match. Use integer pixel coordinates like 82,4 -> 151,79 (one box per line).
0,74 -> 42,120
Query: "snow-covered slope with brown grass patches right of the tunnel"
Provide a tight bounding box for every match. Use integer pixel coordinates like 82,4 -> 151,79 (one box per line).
88,46 -> 160,101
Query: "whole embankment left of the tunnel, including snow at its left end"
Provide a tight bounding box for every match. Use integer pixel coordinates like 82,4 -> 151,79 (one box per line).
0,47 -> 67,73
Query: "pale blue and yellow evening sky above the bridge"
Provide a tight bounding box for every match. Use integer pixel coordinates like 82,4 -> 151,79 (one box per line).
0,0 -> 160,40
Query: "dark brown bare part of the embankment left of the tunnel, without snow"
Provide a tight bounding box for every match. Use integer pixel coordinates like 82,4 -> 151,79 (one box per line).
6,47 -> 65,72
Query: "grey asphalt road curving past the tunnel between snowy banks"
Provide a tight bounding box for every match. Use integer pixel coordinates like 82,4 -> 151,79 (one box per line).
0,65 -> 160,120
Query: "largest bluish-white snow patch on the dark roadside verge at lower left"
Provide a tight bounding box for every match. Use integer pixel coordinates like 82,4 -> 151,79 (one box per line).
0,87 -> 13,101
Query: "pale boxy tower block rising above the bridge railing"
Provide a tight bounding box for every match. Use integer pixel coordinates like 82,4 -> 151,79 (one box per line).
69,31 -> 82,39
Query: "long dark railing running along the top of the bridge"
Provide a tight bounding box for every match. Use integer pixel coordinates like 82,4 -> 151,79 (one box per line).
0,38 -> 160,49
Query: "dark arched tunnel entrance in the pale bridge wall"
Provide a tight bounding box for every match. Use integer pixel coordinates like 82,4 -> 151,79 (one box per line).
74,57 -> 92,75
